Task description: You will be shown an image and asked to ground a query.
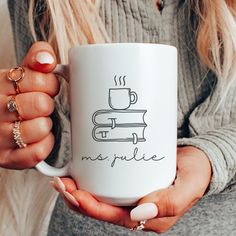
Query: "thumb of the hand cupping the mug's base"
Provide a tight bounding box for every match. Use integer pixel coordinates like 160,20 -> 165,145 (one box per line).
130,175 -> 200,221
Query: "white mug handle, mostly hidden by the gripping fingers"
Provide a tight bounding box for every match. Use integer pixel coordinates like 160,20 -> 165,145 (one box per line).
35,65 -> 70,177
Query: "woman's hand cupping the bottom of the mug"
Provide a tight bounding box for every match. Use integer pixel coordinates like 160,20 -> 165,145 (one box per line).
52,146 -> 211,233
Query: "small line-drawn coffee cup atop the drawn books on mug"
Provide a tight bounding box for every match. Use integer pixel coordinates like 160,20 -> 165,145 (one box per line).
108,88 -> 138,110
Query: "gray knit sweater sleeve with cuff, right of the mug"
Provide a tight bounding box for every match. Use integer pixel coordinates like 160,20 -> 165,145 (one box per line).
178,78 -> 236,194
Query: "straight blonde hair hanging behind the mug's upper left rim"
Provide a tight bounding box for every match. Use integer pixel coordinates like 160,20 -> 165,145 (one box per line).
29,0 -> 110,63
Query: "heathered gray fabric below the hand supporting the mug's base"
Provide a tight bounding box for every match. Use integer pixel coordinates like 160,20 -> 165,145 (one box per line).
48,185 -> 236,236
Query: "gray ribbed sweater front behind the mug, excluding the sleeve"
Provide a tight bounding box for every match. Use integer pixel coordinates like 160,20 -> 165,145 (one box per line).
100,0 -> 214,137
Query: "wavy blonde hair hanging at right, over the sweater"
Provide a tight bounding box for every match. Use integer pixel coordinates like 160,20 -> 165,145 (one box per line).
194,0 -> 236,82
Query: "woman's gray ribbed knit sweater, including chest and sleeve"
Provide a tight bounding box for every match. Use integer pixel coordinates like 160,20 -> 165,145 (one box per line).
9,0 -> 236,234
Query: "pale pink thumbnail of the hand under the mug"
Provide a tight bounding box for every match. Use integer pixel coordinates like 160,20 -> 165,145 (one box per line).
130,203 -> 158,221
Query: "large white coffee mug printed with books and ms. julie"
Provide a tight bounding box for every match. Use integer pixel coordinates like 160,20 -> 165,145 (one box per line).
36,43 -> 177,206
